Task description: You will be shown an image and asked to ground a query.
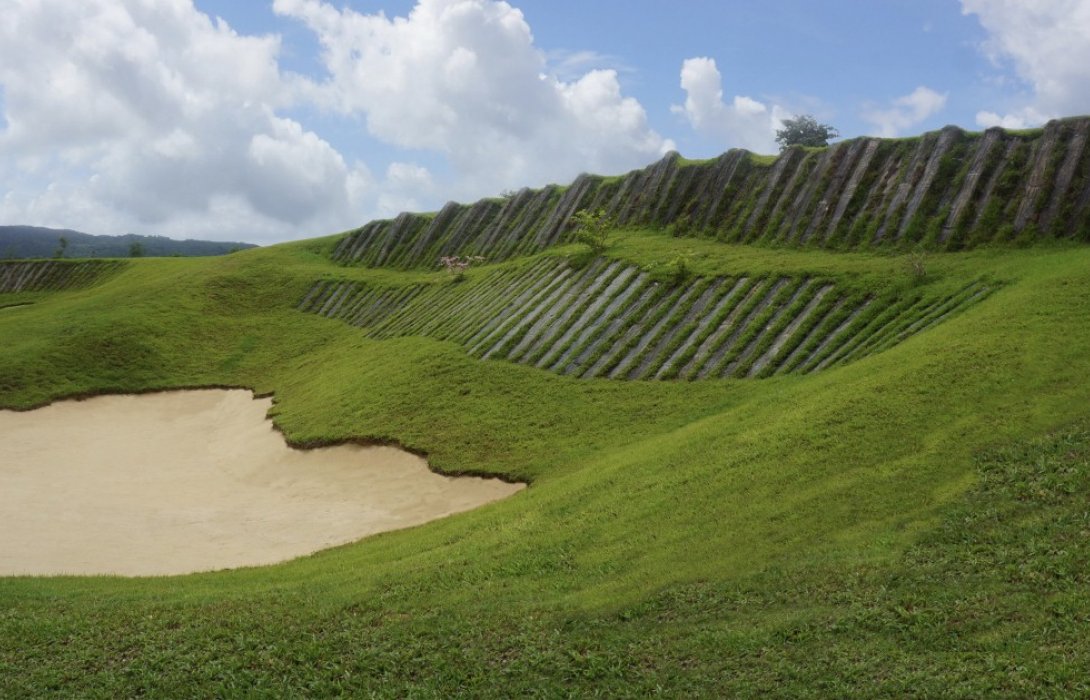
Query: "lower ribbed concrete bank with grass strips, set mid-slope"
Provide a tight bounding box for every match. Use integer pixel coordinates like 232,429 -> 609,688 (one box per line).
299,258 -> 989,379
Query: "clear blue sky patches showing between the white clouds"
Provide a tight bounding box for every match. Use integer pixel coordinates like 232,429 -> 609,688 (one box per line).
195,0 -> 994,163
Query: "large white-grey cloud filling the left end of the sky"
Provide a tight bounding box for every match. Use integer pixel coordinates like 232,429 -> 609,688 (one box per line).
0,0 -> 367,240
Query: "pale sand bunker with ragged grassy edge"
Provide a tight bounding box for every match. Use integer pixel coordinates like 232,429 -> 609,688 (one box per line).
0,390 -> 522,576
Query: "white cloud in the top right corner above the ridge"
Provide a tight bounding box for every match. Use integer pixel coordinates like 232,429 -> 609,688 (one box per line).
961,0 -> 1090,128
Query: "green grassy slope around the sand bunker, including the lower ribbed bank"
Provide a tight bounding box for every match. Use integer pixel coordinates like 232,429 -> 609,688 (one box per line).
0,122 -> 1090,697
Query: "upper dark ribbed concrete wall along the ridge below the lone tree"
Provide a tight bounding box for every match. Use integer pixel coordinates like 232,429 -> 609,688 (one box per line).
334,118 -> 1090,267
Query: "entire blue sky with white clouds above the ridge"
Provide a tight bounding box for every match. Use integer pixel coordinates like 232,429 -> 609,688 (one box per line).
0,0 -> 1090,244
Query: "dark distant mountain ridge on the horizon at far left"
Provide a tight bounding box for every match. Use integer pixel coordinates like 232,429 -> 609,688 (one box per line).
0,226 -> 256,260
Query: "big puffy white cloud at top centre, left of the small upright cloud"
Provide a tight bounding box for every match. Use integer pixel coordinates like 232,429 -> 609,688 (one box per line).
274,0 -> 673,196
